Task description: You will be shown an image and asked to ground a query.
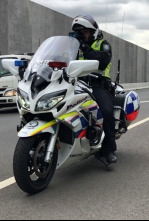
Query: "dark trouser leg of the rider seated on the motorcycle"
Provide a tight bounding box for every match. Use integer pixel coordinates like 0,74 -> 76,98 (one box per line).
92,85 -> 117,153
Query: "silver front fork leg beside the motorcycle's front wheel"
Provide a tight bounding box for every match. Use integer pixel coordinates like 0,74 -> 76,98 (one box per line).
44,123 -> 60,163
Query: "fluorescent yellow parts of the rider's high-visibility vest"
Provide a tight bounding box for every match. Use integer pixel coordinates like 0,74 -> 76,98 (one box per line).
79,40 -> 112,78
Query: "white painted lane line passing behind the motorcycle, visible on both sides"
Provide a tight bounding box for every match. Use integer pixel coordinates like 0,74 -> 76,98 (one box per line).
0,117 -> 149,190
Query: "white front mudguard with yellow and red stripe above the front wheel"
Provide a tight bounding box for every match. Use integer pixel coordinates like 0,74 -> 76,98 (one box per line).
18,120 -> 57,137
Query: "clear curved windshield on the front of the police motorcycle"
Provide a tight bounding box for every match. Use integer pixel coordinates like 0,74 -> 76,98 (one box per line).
24,36 -> 80,80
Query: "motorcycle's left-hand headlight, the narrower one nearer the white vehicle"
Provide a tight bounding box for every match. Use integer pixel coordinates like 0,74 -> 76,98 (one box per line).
17,89 -> 30,110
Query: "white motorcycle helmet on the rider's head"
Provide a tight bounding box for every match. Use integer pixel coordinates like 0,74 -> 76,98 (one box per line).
72,15 -> 102,41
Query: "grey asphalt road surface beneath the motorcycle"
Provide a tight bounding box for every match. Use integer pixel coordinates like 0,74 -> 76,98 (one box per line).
0,89 -> 149,220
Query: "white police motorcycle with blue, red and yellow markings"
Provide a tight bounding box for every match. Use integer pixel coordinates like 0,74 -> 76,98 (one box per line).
2,36 -> 140,194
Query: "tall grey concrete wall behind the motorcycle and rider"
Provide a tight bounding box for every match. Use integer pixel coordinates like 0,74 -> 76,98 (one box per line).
0,0 -> 149,83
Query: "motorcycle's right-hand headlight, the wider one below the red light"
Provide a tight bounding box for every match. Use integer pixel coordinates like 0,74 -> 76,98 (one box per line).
36,95 -> 64,111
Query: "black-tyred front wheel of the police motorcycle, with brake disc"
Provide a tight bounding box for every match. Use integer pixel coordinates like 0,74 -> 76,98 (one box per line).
13,134 -> 58,194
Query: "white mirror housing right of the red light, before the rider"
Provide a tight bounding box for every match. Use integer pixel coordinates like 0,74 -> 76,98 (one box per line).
68,60 -> 99,78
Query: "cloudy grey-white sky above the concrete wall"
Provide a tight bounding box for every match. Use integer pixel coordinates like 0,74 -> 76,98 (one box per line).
31,0 -> 149,50
